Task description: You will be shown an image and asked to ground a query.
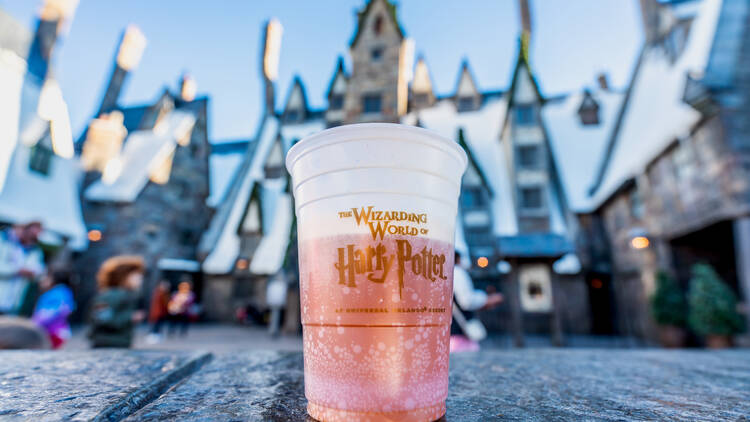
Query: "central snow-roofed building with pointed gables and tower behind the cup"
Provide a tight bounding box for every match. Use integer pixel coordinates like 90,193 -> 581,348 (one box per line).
200,0 -> 622,344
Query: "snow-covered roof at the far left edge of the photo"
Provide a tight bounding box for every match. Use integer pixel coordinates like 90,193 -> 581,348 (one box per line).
0,16 -> 87,250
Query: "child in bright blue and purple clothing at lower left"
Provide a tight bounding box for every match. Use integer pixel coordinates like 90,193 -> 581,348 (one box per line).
31,271 -> 76,349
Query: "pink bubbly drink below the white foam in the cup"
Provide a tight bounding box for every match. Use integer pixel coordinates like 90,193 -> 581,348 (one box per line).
300,234 -> 453,421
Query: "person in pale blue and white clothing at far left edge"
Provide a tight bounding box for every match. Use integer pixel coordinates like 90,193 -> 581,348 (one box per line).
0,221 -> 45,317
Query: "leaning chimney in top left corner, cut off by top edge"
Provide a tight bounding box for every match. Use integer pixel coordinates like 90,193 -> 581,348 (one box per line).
28,0 -> 78,81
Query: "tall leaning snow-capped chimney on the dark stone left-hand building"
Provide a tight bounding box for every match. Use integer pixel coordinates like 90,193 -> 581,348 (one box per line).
96,24 -> 146,117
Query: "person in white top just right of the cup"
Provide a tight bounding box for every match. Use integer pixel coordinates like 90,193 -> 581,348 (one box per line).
450,252 -> 503,353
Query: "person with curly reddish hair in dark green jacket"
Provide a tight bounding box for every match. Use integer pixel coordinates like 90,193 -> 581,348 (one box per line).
89,255 -> 144,348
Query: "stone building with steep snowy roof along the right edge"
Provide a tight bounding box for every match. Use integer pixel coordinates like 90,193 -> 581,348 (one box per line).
591,0 -> 750,338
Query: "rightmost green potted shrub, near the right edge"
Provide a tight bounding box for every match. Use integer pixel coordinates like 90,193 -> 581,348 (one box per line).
688,264 -> 743,336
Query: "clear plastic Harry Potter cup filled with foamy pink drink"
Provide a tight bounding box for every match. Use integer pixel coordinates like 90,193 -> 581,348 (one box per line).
286,123 -> 466,421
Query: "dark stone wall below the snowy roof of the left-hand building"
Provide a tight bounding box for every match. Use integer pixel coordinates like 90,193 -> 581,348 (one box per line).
74,101 -> 211,313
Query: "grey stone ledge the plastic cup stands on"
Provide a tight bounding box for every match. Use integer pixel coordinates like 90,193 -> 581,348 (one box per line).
0,349 -> 750,421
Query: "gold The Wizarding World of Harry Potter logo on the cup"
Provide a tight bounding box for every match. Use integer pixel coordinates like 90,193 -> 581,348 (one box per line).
333,206 -> 448,298
